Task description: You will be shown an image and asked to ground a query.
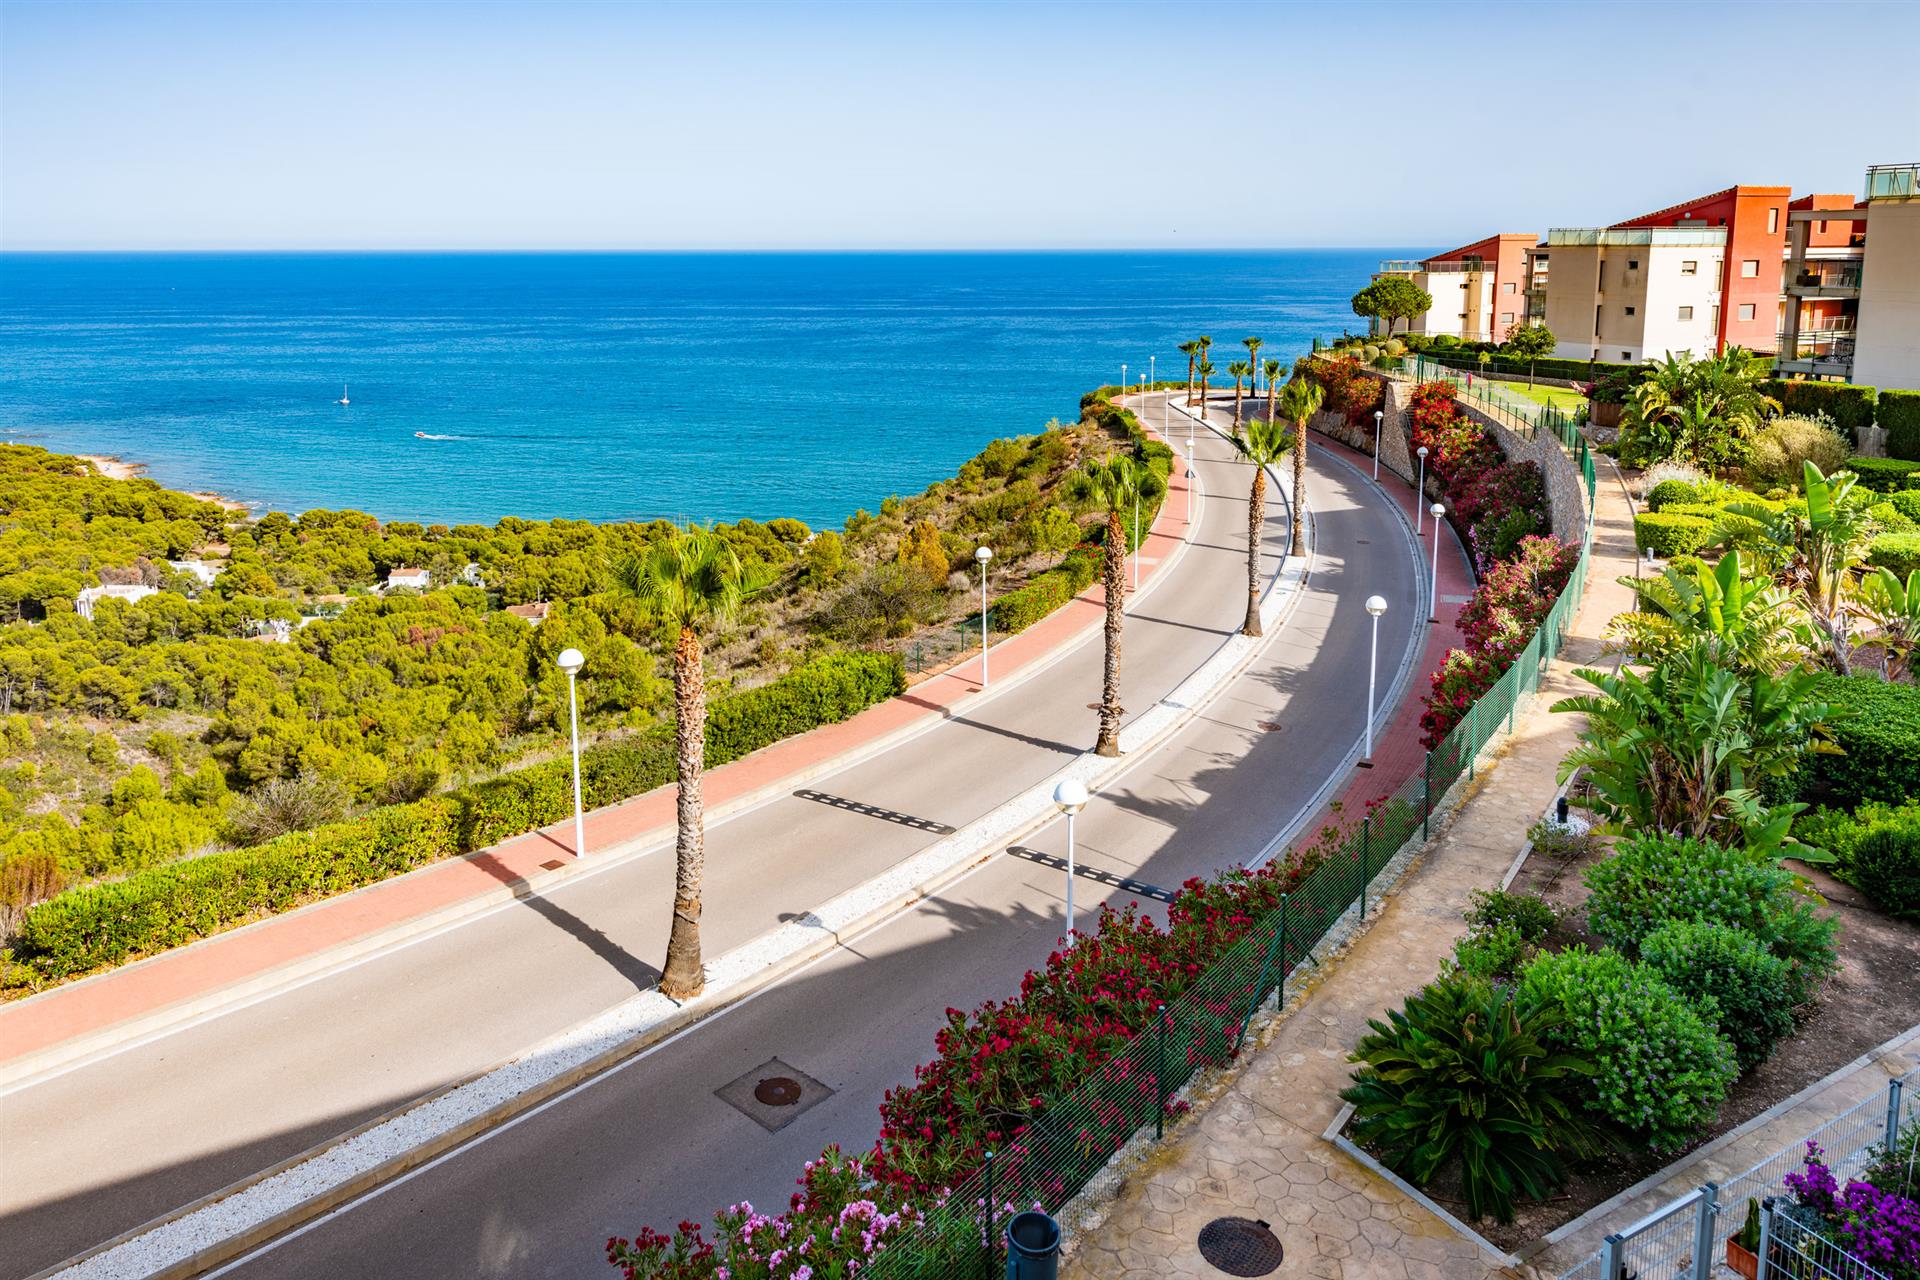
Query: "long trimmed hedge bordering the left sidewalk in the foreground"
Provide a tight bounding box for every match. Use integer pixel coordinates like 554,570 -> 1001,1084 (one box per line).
13,652 -> 906,981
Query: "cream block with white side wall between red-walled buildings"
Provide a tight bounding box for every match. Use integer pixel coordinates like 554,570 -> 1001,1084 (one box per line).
1526,226 -> 1728,365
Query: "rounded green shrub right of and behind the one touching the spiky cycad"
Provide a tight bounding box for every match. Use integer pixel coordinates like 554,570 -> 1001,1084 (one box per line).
1640,919 -> 1795,1071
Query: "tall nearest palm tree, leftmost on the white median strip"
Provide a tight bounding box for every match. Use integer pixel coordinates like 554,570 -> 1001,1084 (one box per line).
612,526 -> 758,1000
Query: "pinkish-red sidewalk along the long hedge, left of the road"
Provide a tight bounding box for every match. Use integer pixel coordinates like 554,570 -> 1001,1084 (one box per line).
0,422 -> 1192,1069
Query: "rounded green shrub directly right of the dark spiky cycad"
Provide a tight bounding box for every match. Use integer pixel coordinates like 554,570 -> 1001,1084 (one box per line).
1521,946 -> 1740,1150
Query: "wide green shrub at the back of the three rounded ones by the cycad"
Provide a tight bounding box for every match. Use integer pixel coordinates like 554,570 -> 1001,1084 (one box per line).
1584,835 -> 1837,1002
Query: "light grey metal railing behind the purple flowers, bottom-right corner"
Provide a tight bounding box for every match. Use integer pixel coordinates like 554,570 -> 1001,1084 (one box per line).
1561,1071 -> 1920,1280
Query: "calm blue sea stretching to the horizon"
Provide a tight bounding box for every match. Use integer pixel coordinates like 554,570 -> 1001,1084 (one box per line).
0,249 -> 1407,526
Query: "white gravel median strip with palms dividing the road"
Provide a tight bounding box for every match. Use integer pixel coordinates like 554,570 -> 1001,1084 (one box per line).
31,412 -> 1313,1280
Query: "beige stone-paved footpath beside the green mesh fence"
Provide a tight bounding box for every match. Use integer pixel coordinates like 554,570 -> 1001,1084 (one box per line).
1066,443 -> 1634,1280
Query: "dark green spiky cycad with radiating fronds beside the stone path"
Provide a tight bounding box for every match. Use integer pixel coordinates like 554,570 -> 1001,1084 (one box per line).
1340,979 -> 1601,1222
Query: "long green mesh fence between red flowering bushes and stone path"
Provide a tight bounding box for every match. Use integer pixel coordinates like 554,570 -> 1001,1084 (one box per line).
860,367 -> 1596,1280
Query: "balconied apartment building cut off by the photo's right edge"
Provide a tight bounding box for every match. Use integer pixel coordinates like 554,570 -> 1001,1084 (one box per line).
1776,165 -> 1920,390
